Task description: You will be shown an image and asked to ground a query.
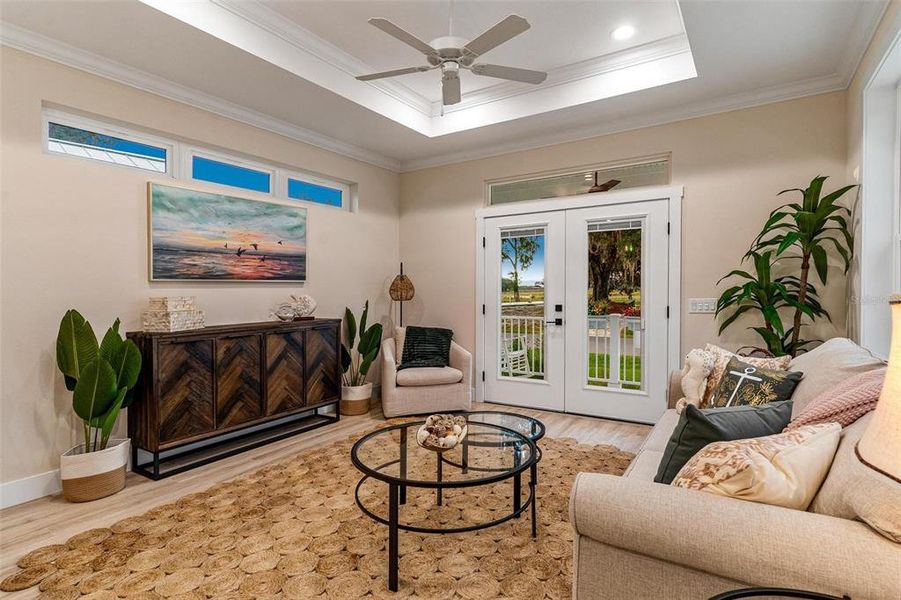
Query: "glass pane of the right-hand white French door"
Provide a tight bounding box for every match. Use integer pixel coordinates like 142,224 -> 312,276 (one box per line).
587,220 -> 645,390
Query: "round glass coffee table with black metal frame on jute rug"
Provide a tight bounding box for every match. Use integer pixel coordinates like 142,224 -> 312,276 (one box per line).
351,411 -> 545,591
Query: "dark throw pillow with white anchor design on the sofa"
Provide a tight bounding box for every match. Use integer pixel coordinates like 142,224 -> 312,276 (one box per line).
709,357 -> 802,408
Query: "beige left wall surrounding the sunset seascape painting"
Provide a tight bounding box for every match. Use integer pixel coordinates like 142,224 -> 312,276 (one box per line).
0,49 -> 399,482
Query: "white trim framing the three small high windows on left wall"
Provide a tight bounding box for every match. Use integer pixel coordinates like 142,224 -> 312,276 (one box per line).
41,106 -> 359,212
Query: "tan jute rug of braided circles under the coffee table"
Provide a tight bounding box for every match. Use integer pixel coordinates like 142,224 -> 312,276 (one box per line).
0,424 -> 632,600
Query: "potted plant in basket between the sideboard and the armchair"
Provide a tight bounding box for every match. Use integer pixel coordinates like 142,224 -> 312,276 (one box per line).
341,300 -> 382,415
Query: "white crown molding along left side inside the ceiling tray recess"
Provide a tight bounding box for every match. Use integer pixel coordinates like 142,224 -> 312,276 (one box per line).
210,0 -> 432,117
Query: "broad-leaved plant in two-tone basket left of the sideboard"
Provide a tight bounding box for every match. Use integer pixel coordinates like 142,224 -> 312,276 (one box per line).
56,310 -> 141,502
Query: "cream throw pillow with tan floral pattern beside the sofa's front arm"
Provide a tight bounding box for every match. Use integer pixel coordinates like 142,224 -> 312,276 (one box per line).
672,423 -> 842,510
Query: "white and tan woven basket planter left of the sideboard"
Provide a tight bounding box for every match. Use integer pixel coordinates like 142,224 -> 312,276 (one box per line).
59,439 -> 129,502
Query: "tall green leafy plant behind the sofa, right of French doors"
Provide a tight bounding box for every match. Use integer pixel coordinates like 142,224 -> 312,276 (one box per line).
716,176 -> 856,356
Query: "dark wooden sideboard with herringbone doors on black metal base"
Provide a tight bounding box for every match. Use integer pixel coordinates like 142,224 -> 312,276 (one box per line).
128,319 -> 341,479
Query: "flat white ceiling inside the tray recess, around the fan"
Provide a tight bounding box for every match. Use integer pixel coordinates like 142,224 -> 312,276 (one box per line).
263,0 -> 684,102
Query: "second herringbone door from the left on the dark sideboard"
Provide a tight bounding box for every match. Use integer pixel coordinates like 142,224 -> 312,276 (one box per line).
216,335 -> 263,428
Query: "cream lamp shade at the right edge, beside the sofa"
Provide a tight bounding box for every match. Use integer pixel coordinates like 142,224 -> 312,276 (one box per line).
857,295 -> 901,481
